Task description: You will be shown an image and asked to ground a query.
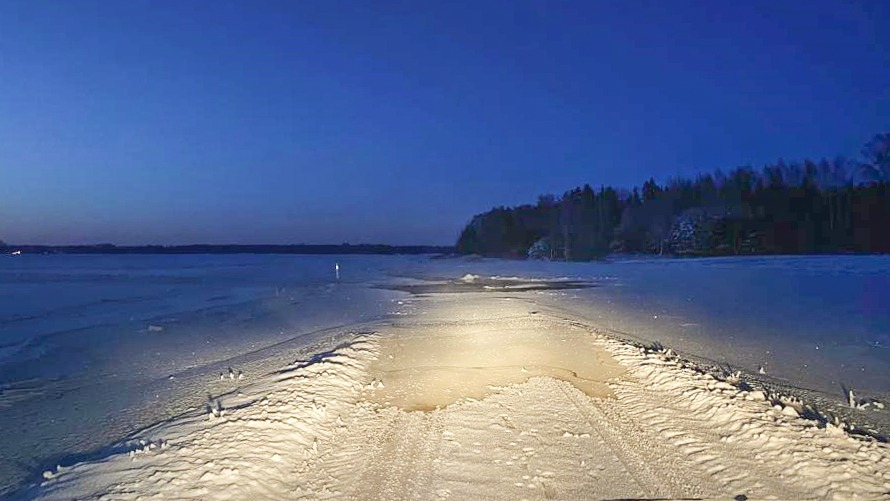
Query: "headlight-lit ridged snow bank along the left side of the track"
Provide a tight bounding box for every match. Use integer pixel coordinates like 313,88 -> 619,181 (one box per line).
39,335 -> 376,500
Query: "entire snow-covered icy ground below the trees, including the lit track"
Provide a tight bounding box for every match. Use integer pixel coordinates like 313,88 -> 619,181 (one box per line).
0,256 -> 890,499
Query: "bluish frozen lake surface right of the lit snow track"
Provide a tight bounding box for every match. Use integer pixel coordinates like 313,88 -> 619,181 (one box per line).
420,256 -> 890,400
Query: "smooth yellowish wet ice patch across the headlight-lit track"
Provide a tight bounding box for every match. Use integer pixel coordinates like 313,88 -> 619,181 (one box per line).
369,318 -> 624,411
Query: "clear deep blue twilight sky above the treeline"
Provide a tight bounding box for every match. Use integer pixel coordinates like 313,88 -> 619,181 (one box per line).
0,0 -> 890,244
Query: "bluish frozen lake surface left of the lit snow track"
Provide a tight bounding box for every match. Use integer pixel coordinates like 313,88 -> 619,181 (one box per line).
0,255 -> 411,492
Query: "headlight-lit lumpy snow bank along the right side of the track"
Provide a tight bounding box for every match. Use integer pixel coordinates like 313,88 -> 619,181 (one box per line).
601,337 -> 890,499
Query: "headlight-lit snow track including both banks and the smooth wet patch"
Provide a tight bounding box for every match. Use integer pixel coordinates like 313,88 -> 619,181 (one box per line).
29,291 -> 890,500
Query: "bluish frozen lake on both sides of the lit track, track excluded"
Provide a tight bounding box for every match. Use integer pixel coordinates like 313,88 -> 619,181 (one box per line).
0,255 -> 890,492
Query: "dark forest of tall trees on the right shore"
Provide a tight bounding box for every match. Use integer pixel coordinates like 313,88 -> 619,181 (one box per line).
456,133 -> 890,260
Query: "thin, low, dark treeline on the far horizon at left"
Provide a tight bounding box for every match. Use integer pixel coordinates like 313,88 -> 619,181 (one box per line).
0,242 -> 454,254
